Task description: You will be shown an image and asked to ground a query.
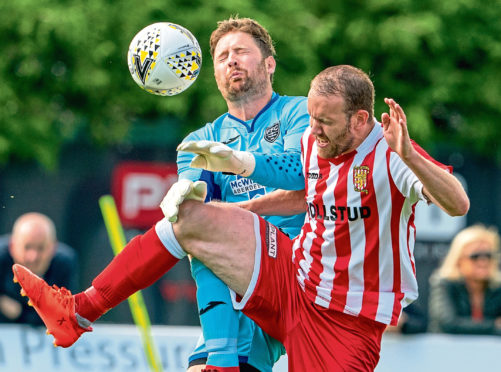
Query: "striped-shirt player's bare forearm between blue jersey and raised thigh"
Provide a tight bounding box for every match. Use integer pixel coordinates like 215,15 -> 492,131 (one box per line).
236,190 -> 307,216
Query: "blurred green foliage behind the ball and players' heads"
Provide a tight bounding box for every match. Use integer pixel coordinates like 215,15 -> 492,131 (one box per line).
0,0 -> 501,167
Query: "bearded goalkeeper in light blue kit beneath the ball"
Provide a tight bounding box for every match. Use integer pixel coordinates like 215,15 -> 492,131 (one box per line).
177,19 -> 309,372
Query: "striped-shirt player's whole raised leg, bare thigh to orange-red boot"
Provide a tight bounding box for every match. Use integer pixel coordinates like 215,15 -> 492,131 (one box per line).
9,200 -> 256,347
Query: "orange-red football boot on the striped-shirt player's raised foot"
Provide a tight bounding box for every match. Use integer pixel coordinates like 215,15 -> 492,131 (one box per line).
12,264 -> 92,347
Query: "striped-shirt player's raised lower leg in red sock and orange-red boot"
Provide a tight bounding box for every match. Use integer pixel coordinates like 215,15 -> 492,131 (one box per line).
12,219 -> 186,347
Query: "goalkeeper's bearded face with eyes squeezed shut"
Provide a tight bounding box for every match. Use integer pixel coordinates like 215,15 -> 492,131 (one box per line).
214,32 -> 275,101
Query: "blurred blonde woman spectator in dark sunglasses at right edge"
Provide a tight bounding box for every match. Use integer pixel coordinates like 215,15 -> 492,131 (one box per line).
429,225 -> 501,335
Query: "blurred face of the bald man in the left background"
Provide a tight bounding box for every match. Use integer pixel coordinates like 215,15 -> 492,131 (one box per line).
10,224 -> 55,275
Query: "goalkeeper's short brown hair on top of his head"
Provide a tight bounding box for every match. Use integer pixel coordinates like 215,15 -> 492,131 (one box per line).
210,17 -> 275,58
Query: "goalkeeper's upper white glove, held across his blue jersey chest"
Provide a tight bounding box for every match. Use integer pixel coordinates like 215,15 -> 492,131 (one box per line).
177,141 -> 256,177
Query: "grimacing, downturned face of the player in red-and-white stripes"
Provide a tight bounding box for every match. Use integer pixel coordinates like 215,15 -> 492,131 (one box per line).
308,92 -> 355,159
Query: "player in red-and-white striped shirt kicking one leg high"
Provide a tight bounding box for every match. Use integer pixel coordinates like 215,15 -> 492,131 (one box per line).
14,66 -> 469,371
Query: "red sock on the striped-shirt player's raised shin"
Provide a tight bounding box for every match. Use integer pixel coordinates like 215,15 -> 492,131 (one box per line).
75,227 -> 179,322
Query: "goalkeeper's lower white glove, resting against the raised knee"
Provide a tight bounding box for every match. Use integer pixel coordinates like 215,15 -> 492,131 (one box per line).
160,179 -> 207,222
